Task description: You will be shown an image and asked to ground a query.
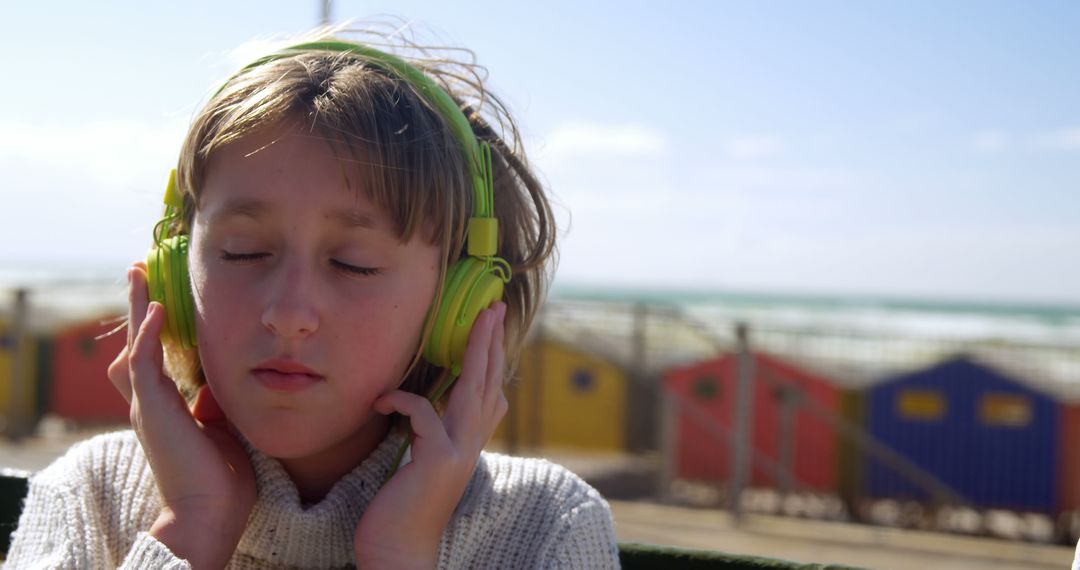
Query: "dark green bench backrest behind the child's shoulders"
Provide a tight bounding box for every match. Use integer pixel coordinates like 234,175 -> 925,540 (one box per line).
0,470 -> 845,570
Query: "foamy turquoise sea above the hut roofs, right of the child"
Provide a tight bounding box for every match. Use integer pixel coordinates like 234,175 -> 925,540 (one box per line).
544,286 -> 1080,388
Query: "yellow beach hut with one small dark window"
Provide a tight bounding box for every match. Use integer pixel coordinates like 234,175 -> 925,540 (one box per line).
495,339 -> 629,451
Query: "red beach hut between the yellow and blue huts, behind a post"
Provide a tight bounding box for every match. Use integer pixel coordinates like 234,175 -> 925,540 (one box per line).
664,352 -> 840,491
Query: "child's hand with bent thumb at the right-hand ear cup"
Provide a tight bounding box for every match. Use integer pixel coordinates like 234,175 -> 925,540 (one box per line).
354,302 -> 508,568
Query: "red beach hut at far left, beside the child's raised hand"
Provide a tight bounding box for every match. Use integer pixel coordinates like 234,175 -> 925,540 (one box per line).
49,318 -> 129,423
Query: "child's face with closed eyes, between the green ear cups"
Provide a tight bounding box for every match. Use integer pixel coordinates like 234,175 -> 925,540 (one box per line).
190,122 -> 441,458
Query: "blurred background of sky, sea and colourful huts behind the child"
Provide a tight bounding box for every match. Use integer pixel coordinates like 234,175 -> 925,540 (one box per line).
0,0 -> 1080,568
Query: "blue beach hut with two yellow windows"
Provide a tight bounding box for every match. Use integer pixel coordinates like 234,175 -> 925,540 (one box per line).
863,355 -> 1062,514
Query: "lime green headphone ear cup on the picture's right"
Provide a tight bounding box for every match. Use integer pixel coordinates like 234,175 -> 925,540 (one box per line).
423,257 -> 504,369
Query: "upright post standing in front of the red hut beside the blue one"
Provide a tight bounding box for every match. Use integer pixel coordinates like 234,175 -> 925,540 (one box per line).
728,323 -> 754,523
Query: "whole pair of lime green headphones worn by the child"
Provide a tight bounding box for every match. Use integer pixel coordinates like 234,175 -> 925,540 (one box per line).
147,41 -> 511,377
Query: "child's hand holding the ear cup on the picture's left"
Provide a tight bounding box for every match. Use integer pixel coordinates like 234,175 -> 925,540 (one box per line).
109,263 -> 256,568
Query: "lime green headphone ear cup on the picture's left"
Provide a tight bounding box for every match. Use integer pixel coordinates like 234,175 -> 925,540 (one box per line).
146,235 -> 195,349
